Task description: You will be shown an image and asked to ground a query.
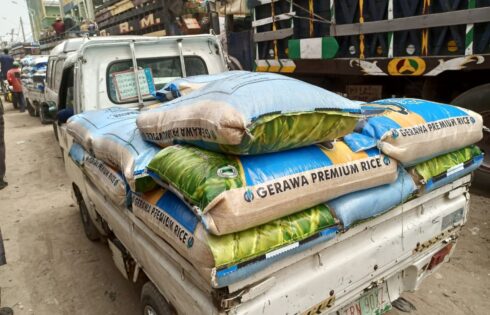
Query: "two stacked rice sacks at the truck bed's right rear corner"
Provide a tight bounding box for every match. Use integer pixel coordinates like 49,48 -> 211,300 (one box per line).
345,98 -> 483,193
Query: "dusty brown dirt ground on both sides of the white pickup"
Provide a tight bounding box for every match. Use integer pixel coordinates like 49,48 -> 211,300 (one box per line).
0,104 -> 490,315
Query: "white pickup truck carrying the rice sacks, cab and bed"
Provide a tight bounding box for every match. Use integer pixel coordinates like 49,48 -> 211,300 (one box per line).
53,35 -> 471,315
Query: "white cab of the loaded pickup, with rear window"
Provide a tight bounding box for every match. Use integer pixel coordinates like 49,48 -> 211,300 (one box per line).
54,35 -> 227,242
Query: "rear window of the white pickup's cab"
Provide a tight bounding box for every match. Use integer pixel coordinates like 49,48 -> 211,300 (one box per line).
107,56 -> 208,104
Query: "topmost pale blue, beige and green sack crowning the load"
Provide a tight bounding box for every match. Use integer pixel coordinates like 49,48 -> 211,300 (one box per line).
137,71 -> 361,155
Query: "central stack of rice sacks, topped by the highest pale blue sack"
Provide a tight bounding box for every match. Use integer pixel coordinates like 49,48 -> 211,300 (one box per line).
133,71 -> 404,287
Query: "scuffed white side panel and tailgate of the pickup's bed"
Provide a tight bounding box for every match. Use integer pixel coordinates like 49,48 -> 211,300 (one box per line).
84,175 -> 471,314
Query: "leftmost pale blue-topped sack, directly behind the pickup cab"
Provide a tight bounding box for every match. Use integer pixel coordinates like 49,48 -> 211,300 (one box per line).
66,107 -> 139,152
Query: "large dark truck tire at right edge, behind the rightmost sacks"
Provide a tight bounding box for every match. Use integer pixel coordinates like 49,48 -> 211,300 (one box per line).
451,83 -> 490,187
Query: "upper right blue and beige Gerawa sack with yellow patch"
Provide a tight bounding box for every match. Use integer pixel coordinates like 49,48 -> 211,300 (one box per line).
345,98 -> 483,166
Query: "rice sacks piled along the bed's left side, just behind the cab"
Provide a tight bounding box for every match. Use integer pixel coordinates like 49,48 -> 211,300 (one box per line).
67,107 -> 160,206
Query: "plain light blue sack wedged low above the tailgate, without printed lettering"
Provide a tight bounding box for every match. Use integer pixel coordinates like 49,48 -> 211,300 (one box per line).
327,167 -> 417,228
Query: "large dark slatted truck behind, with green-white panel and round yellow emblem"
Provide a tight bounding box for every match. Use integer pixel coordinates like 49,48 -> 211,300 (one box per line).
235,0 -> 490,183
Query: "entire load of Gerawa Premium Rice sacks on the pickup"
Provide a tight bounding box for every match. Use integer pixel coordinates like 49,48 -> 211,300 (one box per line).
67,71 -> 482,287
